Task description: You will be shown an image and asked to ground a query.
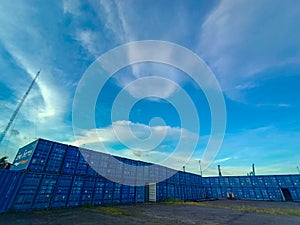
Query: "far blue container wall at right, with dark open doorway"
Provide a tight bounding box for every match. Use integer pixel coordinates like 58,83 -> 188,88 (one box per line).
202,175 -> 300,201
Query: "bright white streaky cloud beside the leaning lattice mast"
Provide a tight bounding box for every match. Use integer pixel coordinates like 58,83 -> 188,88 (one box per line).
0,1 -> 68,119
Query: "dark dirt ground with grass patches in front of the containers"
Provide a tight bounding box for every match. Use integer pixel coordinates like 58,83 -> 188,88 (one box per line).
0,200 -> 300,225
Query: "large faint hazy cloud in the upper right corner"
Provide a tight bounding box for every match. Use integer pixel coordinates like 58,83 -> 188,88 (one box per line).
198,0 -> 300,101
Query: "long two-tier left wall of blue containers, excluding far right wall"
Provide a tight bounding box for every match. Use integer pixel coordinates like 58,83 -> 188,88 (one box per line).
0,139 -> 204,212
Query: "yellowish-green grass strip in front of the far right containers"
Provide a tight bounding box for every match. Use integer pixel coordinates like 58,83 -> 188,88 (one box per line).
168,202 -> 300,216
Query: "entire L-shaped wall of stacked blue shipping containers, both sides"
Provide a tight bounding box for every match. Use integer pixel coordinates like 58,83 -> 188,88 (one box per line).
0,139 -> 300,212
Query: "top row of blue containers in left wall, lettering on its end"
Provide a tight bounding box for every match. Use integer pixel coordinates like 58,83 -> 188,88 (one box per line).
12,139 -> 196,185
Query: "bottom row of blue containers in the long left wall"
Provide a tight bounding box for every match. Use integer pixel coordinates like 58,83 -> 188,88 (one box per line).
0,171 -> 204,212
